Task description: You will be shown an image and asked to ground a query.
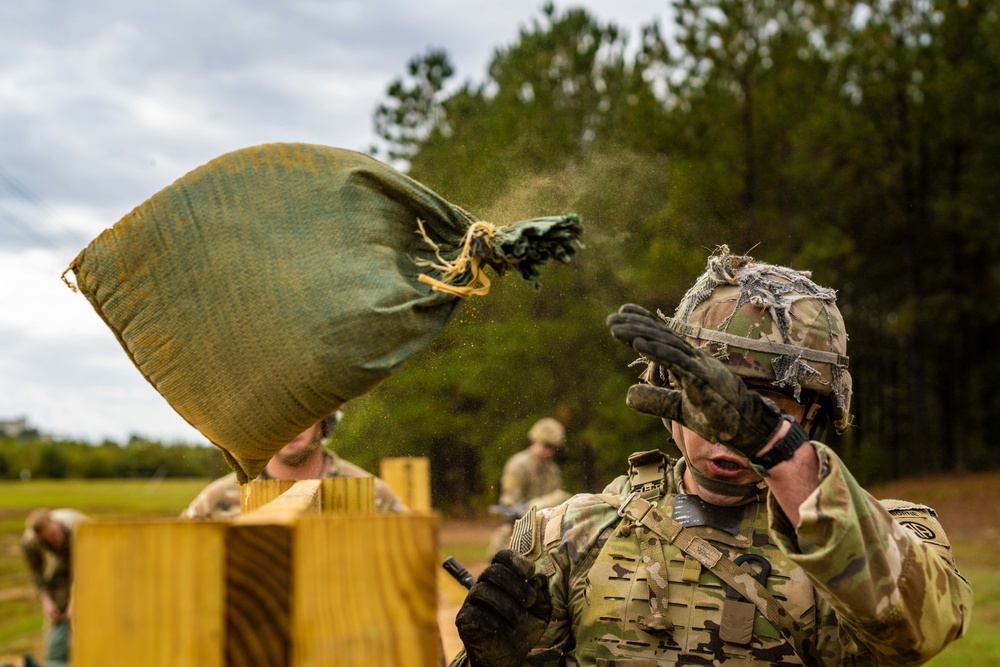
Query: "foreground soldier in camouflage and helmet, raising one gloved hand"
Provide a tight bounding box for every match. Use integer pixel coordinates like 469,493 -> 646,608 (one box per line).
453,247 -> 972,667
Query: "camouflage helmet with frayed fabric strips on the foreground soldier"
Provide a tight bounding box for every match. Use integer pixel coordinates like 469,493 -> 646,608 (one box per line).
645,245 -> 851,433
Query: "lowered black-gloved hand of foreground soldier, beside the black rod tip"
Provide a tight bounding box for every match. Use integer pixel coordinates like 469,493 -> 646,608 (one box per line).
455,549 -> 552,667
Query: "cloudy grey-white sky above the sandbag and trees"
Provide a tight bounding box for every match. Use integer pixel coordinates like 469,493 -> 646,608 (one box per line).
0,0 -> 668,442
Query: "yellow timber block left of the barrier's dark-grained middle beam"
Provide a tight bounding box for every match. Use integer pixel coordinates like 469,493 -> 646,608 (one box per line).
70,521 -> 227,667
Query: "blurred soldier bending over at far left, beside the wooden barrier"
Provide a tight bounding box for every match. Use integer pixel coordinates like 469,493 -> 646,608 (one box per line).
21,508 -> 88,665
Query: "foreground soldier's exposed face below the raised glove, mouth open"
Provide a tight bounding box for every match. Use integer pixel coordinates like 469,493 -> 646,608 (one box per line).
671,394 -> 805,506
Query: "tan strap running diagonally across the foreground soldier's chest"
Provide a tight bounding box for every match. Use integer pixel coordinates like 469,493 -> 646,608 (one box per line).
597,492 -> 803,658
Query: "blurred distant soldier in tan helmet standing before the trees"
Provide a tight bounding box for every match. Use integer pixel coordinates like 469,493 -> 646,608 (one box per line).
487,417 -> 569,558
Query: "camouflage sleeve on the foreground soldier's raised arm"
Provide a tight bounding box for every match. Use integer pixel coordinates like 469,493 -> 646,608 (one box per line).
769,443 -> 972,664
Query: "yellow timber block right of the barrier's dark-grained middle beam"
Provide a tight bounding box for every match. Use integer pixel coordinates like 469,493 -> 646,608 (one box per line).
290,514 -> 440,667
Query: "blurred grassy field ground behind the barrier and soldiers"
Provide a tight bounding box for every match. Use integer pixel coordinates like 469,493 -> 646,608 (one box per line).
0,472 -> 1000,667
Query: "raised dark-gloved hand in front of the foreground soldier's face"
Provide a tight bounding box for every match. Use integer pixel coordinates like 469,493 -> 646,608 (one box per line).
607,304 -> 781,458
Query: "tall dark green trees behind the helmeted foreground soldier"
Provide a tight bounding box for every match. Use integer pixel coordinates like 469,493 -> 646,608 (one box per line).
332,0 -> 1000,516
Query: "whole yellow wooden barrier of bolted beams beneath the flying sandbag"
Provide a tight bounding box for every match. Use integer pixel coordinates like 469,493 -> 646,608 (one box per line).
71,478 -> 441,667
